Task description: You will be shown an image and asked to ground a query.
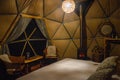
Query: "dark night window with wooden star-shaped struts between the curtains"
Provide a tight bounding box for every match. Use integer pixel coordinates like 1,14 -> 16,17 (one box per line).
9,19 -> 46,57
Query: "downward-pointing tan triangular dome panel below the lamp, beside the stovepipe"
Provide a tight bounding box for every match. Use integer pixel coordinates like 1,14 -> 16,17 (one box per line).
64,20 -> 80,37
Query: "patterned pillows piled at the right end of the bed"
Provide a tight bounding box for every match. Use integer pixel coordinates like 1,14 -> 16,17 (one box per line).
87,56 -> 118,80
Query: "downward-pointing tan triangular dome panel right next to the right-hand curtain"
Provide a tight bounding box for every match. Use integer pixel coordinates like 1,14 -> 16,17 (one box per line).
45,19 -> 61,38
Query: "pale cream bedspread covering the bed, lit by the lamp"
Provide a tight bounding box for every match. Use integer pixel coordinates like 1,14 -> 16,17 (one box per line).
17,58 -> 99,80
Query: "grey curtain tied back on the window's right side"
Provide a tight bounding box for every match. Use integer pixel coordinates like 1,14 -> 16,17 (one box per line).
36,19 -> 52,46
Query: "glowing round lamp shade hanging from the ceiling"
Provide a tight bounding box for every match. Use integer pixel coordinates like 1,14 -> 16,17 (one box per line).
62,0 -> 75,13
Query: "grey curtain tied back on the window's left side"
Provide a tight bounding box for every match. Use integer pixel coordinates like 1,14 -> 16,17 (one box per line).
2,17 -> 31,54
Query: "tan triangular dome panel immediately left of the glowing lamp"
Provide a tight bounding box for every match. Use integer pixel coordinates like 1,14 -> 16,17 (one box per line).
47,8 -> 64,22
